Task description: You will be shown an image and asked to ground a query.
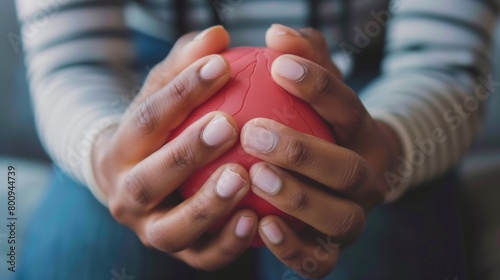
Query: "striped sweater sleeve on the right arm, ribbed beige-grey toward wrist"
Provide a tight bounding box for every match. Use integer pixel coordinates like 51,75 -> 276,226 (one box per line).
361,0 -> 499,201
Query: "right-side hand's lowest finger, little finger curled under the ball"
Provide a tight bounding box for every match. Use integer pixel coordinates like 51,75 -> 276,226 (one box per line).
259,216 -> 339,278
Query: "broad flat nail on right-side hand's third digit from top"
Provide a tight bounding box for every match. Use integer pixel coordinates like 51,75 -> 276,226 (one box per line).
243,124 -> 276,153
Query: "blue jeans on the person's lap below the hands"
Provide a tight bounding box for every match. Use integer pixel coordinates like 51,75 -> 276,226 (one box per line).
16,31 -> 465,280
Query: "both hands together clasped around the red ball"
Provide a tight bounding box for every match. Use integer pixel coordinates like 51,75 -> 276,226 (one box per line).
92,25 -> 400,277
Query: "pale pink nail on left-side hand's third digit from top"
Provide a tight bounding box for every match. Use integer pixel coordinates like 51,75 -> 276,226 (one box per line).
201,115 -> 236,146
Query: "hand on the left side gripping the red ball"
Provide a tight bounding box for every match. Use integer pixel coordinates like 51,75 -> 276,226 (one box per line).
92,26 -> 257,270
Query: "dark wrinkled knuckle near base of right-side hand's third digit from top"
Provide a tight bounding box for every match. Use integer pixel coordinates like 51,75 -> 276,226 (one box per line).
337,153 -> 368,192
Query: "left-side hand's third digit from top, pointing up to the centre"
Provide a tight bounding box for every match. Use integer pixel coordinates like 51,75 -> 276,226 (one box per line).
110,112 -> 238,209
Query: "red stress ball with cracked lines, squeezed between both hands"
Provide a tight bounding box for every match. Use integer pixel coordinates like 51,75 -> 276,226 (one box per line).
172,47 -> 334,247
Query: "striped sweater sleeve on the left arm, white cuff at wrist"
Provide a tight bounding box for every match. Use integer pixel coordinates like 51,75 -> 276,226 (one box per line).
16,0 -> 138,194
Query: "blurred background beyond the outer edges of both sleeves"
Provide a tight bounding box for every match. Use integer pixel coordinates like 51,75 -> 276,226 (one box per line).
0,1 -> 500,280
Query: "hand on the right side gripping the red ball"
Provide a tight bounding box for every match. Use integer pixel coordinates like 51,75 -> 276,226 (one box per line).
241,25 -> 401,277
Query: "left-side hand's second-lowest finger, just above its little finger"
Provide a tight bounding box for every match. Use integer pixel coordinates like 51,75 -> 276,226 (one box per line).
145,164 -> 249,253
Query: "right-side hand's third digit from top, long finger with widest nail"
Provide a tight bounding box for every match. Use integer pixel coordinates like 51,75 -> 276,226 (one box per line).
240,118 -> 387,203
